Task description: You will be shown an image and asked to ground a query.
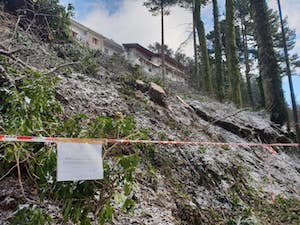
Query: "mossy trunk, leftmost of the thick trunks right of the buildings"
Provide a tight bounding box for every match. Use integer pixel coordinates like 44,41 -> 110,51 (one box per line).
195,0 -> 213,93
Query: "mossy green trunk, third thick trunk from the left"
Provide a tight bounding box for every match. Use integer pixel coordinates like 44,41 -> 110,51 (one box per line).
226,0 -> 242,107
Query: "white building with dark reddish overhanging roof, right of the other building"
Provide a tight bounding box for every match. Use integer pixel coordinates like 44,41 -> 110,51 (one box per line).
123,43 -> 187,83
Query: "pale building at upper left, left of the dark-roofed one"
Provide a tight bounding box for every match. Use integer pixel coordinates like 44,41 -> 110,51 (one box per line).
70,20 -> 124,55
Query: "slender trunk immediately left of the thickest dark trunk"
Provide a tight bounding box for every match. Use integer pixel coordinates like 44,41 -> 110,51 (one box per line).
241,18 -> 255,109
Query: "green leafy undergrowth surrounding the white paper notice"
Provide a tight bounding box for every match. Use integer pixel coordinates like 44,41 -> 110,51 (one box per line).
0,58 -> 154,224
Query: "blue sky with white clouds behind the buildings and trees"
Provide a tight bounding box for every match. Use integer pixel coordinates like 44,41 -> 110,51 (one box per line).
60,0 -> 300,104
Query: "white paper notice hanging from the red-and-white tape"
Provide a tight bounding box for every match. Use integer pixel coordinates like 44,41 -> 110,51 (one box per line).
57,143 -> 103,181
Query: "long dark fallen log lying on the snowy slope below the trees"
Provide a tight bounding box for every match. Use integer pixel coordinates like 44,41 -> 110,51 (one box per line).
190,101 -> 292,143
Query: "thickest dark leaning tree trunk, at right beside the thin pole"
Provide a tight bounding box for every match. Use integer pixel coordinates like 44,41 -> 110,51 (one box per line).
250,0 -> 287,125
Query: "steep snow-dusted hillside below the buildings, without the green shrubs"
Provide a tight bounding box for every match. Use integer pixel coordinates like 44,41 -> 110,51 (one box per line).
0,11 -> 300,225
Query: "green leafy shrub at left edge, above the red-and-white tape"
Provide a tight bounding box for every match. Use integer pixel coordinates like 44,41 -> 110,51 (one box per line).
0,70 -> 63,136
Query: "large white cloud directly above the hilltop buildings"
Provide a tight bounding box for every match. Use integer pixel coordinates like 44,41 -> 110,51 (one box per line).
75,0 -> 198,55
